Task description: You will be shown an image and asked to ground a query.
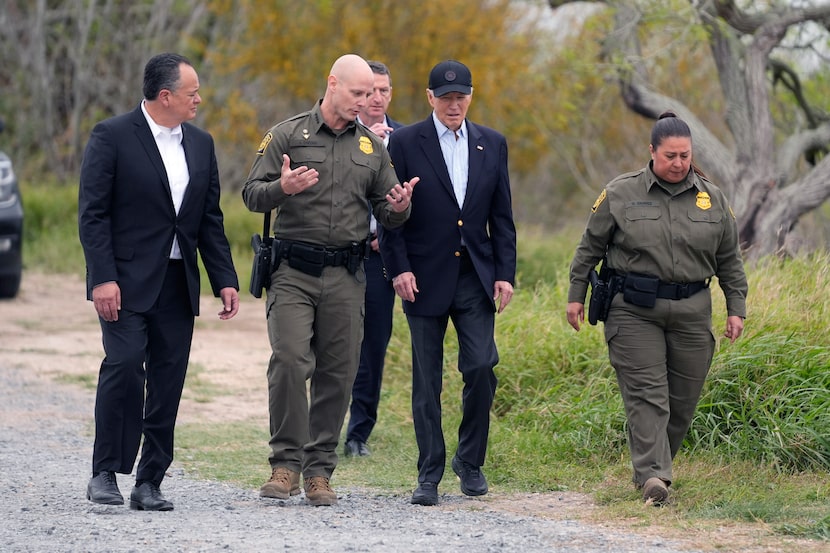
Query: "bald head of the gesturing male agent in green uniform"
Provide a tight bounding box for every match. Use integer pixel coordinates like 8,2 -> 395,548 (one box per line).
320,54 -> 375,130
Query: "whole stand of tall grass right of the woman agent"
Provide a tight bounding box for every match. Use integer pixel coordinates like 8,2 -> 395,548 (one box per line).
686,253 -> 830,473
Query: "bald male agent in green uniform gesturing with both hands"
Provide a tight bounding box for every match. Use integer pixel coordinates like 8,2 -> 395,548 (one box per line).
242,54 -> 417,505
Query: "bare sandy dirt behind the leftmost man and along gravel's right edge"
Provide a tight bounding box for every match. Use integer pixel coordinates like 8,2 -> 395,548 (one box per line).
0,273 -> 830,553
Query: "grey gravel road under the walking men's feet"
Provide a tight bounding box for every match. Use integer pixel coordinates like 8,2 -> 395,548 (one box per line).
0,359 -> 708,553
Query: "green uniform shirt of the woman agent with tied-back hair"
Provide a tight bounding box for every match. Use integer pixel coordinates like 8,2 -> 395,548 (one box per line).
568,166 -> 747,317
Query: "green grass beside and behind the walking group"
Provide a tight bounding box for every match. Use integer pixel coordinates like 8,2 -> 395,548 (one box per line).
24,180 -> 830,540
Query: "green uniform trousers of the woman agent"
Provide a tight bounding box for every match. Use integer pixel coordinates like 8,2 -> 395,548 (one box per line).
605,288 -> 715,486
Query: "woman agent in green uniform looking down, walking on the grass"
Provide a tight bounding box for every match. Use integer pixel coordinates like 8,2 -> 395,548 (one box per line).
567,112 -> 747,504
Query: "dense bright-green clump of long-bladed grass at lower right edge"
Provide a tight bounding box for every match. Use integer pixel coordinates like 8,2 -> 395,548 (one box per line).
687,327 -> 830,473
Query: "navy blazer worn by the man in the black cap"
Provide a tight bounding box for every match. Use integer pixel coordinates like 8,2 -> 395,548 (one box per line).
380,114 -> 516,316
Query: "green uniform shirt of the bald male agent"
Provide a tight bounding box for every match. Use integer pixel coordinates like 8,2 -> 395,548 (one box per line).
242,102 -> 410,248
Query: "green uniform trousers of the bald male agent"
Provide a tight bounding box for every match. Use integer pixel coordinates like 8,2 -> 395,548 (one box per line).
266,261 -> 366,479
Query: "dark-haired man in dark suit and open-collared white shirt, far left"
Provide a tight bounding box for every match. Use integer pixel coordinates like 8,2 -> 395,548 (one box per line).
78,54 -> 239,511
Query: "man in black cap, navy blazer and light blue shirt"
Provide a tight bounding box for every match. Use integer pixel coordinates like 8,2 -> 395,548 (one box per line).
380,60 -> 516,505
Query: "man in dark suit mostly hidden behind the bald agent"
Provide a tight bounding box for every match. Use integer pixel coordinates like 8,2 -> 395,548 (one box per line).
344,60 -> 403,457
